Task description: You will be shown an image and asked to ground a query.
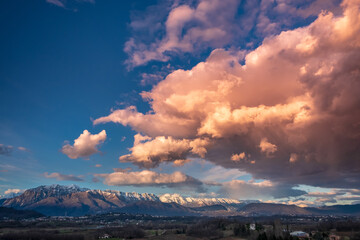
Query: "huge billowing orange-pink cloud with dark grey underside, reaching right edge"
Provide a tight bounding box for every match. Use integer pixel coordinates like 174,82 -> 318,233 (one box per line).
94,0 -> 360,188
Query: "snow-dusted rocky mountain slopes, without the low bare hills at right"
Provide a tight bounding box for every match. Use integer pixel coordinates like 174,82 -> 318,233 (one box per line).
2,185 -> 241,214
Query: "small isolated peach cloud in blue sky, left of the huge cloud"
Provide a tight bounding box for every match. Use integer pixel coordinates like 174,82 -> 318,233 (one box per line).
61,130 -> 106,159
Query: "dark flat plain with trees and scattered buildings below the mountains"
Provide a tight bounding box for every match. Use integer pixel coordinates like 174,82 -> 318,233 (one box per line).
0,213 -> 360,240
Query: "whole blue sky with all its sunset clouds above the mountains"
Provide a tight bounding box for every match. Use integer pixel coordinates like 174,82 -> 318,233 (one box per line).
0,0 -> 360,207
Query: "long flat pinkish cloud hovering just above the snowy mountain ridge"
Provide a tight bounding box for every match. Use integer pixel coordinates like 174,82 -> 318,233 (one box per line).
94,170 -> 202,188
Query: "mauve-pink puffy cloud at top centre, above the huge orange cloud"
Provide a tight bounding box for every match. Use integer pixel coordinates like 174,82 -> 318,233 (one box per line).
124,0 -> 240,66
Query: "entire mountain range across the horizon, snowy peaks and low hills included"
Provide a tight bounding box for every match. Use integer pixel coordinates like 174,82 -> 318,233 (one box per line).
0,185 -> 360,216
